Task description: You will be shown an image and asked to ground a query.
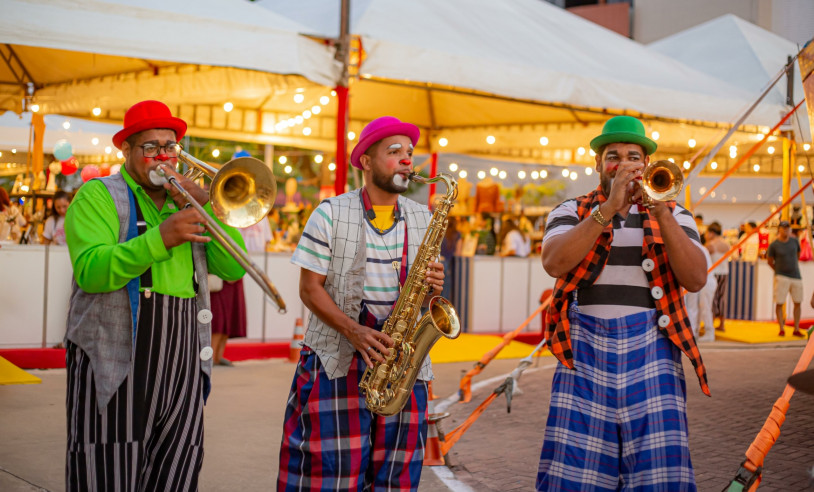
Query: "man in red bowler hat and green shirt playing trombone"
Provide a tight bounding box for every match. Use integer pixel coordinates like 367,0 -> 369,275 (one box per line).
65,101 -> 245,491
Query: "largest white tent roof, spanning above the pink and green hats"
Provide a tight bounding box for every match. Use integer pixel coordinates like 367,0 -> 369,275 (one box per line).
260,0 -> 775,126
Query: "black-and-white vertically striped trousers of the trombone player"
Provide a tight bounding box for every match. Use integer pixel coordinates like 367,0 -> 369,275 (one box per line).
65,293 -> 204,491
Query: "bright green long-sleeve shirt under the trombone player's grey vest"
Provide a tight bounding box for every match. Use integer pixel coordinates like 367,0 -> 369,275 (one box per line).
65,166 -> 246,298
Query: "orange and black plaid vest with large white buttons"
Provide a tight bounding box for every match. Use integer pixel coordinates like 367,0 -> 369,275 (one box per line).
545,187 -> 710,396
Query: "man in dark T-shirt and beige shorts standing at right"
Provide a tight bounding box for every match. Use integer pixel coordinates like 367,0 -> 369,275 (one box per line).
766,220 -> 805,337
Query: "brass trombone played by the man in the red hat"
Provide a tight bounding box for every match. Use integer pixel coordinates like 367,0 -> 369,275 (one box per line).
156,147 -> 286,314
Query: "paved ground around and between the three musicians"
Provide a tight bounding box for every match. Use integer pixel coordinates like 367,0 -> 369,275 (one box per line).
0,342 -> 814,492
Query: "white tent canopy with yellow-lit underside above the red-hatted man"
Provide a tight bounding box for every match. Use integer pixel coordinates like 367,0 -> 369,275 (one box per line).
0,0 -> 338,112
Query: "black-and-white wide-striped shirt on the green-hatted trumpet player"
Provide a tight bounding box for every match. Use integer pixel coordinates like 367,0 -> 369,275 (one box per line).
543,200 -> 704,319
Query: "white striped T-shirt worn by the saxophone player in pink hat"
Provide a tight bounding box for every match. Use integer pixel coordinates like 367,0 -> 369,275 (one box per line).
291,202 -> 405,320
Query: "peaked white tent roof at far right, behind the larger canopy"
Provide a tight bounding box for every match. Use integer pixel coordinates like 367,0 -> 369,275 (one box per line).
648,14 -> 811,141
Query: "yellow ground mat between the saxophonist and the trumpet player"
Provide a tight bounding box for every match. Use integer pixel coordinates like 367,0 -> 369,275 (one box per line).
430,333 -> 551,363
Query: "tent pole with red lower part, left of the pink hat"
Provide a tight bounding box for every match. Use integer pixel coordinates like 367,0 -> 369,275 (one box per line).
334,0 -> 350,195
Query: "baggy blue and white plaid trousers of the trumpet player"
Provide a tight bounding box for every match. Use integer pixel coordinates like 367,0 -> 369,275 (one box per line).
537,310 -> 696,492
